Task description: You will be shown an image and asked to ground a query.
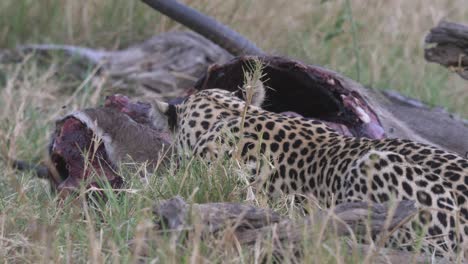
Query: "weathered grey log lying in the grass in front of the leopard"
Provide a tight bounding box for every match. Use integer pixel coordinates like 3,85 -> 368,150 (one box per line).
153,197 -> 417,237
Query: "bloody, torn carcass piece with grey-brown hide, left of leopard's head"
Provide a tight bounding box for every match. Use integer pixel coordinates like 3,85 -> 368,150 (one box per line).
49,95 -> 171,194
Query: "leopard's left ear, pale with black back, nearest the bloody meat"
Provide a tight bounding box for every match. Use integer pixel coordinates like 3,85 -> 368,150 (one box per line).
150,100 -> 177,130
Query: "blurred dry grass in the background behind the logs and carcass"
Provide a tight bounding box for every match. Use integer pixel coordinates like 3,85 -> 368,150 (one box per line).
0,0 -> 468,113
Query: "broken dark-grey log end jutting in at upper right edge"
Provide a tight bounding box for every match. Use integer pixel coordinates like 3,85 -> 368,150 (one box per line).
424,21 -> 468,80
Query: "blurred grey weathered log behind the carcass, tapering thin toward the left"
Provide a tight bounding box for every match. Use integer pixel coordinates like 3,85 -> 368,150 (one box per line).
16,32 -> 232,99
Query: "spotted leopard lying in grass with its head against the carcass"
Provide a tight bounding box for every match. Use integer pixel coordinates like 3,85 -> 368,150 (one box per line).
152,86 -> 468,259
